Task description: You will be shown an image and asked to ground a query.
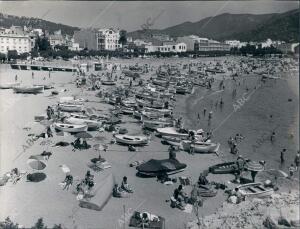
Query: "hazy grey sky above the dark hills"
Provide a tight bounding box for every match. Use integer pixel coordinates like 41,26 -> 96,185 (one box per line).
0,0 -> 299,32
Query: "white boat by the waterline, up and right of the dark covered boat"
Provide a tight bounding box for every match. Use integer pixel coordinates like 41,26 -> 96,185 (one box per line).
182,140 -> 220,153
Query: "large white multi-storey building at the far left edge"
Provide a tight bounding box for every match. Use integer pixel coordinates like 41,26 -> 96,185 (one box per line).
0,33 -> 32,54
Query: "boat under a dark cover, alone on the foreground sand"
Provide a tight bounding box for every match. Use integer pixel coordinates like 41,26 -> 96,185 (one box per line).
136,159 -> 187,177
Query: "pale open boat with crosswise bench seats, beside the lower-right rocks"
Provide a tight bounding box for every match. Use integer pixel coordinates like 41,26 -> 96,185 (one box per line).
237,182 -> 274,198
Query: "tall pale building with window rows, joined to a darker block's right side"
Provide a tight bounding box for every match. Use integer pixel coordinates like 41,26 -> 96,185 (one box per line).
97,29 -> 121,51
